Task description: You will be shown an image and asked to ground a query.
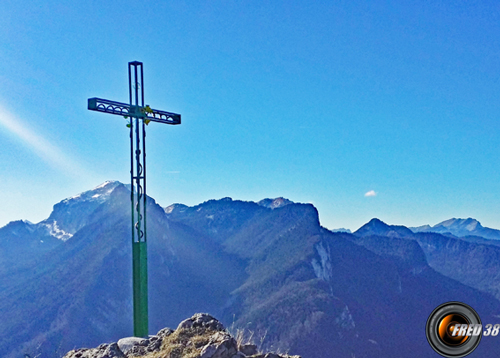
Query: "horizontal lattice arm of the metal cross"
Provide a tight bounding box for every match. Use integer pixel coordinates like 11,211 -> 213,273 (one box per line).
88,97 -> 181,124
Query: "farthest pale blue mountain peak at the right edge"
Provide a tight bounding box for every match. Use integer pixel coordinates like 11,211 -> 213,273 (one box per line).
410,218 -> 500,240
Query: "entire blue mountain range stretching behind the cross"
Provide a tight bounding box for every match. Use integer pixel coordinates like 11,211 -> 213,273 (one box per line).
0,181 -> 500,358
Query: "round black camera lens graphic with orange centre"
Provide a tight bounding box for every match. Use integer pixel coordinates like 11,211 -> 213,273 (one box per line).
425,302 -> 482,358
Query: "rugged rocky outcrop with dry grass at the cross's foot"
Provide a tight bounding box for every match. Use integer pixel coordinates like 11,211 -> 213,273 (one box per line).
64,313 -> 300,358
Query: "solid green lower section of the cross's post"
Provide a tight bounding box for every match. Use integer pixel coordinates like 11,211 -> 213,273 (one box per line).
132,242 -> 149,337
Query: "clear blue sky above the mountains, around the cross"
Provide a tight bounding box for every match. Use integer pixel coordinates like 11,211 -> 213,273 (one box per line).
0,0 -> 500,229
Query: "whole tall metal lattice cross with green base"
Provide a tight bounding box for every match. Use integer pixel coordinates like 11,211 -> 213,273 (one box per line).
88,61 -> 181,337
